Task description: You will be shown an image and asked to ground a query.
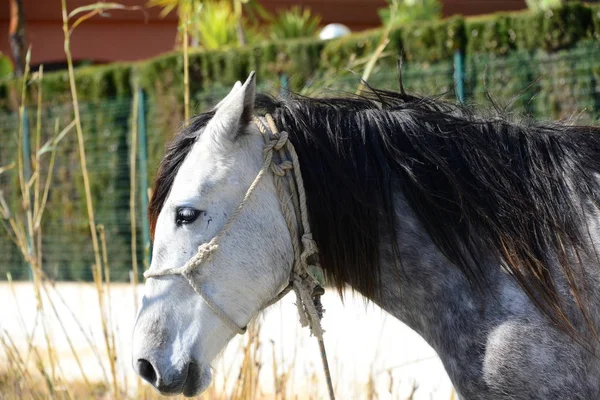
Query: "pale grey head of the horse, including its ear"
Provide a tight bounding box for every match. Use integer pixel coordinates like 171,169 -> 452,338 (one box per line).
133,74 -> 293,396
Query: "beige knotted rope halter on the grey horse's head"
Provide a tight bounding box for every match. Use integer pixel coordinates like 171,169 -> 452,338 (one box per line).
144,114 -> 335,400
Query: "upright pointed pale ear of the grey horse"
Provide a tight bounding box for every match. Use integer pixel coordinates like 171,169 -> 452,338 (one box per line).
207,72 -> 256,144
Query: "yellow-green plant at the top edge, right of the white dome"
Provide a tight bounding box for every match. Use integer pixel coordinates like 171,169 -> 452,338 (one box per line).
378,0 -> 442,25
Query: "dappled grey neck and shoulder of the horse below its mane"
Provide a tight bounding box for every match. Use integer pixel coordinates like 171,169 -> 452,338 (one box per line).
372,190 -> 600,399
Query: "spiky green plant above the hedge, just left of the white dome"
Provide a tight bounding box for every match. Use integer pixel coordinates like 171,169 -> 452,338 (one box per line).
269,6 -> 321,40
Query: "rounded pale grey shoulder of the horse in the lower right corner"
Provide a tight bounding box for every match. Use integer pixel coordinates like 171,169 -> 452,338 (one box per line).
482,318 -> 600,399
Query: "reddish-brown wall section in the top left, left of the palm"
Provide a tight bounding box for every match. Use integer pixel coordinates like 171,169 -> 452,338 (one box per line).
0,0 -> 177,65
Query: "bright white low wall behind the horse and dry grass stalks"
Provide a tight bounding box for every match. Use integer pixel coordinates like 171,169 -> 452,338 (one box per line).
0,282 -> 452,399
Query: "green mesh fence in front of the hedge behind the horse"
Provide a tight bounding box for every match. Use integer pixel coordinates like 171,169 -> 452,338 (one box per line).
0,41 -> 600,281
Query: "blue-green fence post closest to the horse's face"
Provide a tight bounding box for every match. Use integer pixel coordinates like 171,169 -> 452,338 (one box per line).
134,89 -> 151,269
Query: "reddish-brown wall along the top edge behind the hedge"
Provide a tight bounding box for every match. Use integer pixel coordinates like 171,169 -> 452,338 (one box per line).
0,0 -> 525,65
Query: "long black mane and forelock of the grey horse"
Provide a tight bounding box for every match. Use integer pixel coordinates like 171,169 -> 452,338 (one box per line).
150,83 -> 600,334
